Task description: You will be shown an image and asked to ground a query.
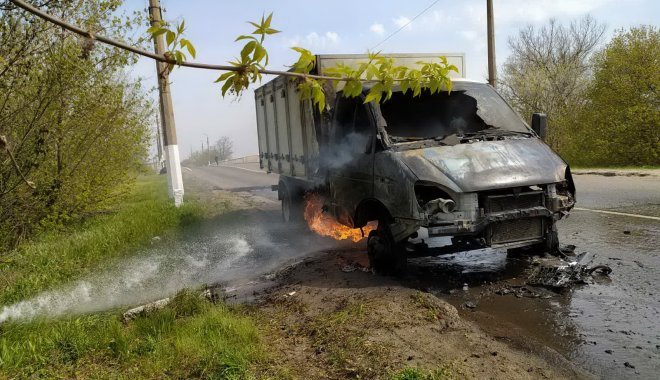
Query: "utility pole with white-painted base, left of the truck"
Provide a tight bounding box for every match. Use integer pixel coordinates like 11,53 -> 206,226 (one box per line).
149,0 -> 183,207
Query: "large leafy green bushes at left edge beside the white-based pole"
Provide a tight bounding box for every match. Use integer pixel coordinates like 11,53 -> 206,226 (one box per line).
0,0 -> 152,250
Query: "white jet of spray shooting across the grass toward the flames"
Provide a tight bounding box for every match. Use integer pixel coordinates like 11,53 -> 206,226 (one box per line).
0,213 -> 336,323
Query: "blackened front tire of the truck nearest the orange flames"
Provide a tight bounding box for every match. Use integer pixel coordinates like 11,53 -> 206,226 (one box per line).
367,222 -> 407,275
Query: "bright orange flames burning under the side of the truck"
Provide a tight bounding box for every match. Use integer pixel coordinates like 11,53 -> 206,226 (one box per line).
304,194 -> 378,242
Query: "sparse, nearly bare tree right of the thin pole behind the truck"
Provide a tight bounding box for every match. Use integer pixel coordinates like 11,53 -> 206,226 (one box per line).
499,16 -> 605,151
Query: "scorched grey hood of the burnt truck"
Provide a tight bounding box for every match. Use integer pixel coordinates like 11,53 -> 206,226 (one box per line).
398,138 -> 566,192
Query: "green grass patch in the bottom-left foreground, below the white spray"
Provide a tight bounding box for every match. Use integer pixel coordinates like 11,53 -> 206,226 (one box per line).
0,292 -> 264,379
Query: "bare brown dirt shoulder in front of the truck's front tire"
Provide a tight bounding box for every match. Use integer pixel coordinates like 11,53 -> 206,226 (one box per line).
246,252 -> 588,379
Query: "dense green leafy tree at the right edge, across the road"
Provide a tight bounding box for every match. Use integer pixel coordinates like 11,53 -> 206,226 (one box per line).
570,26 -> 660,165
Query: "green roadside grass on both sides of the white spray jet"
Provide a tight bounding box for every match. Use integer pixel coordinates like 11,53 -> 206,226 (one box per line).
0,176 -> 263,379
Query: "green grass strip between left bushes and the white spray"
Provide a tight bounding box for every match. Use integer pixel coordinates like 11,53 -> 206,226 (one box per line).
0,175 -> 202,304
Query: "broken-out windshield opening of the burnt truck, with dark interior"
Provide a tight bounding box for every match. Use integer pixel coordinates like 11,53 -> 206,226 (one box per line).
380,83 -> 529,141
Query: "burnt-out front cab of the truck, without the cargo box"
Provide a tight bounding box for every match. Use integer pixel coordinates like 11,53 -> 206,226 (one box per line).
319,79 -> 575,270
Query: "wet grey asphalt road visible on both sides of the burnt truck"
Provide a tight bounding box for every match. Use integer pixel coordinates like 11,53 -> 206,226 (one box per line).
192,164 -> 660,379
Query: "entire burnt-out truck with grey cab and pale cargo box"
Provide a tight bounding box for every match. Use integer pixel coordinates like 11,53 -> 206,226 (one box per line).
255,53 -> 575,273
